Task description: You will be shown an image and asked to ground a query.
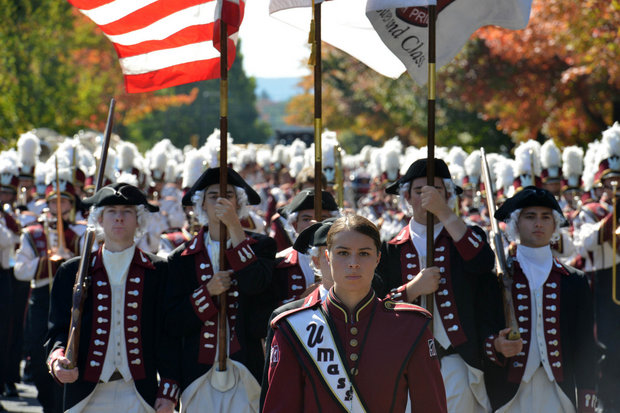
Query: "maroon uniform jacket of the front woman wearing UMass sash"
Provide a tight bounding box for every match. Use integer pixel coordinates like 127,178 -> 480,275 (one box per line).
263,289 -> 447,413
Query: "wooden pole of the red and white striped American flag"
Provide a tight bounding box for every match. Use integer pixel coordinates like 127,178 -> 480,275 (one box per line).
217,19 -> 228,371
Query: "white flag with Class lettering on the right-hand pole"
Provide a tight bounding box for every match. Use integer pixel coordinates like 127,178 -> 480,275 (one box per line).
366,0 -> 532,85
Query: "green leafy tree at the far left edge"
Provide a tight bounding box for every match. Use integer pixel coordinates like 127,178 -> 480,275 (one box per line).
0,0 -> 79,143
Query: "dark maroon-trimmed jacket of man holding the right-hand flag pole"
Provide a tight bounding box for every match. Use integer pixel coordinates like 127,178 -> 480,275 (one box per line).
375,225 -> 496,369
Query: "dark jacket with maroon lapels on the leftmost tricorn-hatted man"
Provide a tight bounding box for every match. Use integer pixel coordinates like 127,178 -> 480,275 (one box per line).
47,247 -> 179,409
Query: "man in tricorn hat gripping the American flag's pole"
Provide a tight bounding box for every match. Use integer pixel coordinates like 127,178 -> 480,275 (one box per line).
165,167 -> 276,412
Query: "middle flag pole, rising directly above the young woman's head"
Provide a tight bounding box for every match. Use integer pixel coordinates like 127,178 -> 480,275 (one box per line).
309,0 -> 323,221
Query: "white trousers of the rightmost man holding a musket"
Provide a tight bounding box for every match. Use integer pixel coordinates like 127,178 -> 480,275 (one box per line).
497,367 -> 575,413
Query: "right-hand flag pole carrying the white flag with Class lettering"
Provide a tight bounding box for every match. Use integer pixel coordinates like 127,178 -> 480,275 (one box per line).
425,5 -> 437,326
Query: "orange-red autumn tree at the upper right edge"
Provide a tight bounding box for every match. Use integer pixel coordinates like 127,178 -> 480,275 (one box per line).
441,0 -> 620,145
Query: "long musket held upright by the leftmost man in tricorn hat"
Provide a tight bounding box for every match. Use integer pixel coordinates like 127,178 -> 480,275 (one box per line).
65,98 -> 116,369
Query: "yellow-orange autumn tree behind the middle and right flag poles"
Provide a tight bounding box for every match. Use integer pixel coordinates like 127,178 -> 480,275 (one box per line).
286,45 -> 510,151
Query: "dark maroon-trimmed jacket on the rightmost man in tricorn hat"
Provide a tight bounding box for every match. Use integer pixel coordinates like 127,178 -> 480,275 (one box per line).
484,254 -> 598,412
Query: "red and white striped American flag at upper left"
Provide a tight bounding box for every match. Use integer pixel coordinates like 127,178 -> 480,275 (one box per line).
68,0 -> 245,93
